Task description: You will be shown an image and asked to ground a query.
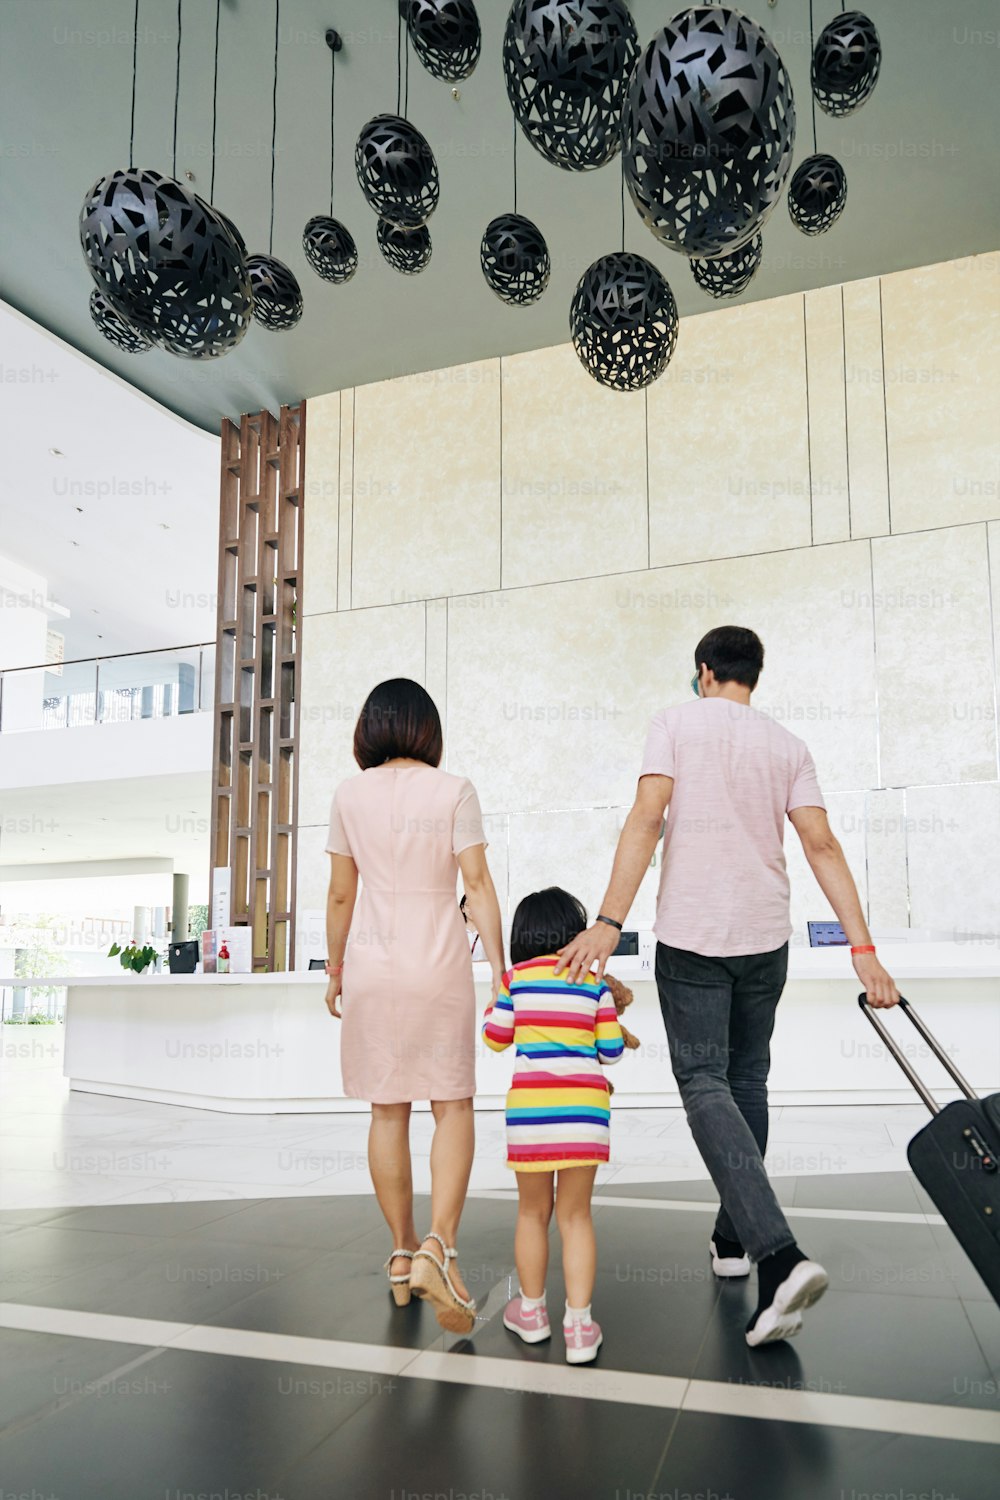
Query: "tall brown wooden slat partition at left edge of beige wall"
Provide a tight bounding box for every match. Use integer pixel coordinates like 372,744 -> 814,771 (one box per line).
211,401 -> 306,971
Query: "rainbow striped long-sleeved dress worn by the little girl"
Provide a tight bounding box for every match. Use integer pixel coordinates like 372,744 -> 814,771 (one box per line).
483,954 -> 624,1172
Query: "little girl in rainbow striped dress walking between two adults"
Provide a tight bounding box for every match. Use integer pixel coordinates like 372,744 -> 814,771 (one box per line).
483,887 -> 624,1365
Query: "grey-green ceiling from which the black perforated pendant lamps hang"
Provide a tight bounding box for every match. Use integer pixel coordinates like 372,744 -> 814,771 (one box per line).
0,0 -> 1000,435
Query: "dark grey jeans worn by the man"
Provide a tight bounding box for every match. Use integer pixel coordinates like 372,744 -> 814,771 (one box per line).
657,944 -> 795,1260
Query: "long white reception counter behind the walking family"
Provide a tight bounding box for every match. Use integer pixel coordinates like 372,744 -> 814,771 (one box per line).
9,942 -> 1000,1113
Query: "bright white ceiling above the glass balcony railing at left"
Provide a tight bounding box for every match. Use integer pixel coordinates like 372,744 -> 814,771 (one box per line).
0,303 -> 219,666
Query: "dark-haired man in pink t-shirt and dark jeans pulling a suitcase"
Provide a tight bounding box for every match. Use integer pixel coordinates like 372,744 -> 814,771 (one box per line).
562,626 -> 900,1346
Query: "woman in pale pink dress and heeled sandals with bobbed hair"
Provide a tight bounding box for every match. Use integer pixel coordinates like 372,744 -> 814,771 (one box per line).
327,678 -> 504,1334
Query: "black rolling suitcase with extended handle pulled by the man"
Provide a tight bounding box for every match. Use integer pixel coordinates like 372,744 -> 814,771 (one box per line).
858,995 -> 1000,1304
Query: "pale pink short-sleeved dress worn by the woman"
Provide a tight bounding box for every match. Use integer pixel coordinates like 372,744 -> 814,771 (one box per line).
327,765 -> 486,1104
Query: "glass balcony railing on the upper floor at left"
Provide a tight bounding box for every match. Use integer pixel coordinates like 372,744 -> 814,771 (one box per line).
0,641 -> 216,734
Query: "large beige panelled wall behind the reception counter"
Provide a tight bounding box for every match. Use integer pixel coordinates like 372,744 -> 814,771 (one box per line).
298,255 -> 1000,933
